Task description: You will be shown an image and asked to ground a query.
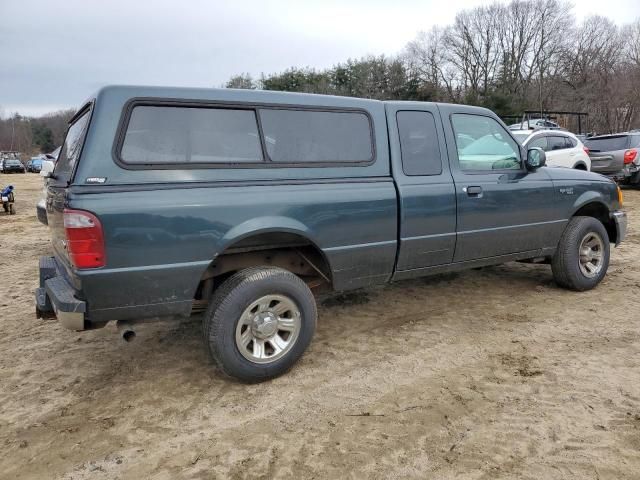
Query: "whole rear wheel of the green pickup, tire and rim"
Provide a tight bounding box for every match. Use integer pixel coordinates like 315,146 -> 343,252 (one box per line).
203,267 -> 317,382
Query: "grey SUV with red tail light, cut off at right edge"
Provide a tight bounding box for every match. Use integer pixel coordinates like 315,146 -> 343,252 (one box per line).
584,132 -> 640,185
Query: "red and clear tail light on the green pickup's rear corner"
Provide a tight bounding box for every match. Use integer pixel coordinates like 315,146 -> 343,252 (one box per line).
64,209 -> 106,268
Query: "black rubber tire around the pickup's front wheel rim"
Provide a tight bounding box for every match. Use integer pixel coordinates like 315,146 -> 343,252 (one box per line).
551,217 -> 610,292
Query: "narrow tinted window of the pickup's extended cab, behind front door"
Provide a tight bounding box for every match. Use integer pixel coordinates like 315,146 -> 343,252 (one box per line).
396,112 -> 442,175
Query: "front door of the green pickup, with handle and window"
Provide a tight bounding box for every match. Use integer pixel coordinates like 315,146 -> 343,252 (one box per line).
440,105 -> 563,262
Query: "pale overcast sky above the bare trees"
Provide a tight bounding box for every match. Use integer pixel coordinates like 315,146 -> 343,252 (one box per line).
0,0 -> 640,116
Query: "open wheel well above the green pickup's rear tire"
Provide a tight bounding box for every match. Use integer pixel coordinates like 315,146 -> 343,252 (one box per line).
194,232 -> 332,310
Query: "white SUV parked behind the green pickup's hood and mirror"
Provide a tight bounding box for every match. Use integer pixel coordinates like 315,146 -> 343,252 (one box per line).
511,130 -> 591,170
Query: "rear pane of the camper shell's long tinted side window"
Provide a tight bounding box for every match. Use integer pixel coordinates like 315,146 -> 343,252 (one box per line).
120,106 -> 262,164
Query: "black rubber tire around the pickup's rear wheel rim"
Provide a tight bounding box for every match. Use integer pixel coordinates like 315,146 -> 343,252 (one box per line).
202,266 -> 318,383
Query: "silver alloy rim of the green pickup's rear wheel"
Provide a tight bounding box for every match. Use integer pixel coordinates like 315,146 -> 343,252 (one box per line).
235,295 -> 302,364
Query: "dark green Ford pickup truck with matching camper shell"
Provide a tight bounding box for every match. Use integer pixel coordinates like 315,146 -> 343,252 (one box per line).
36,87 -> 626,381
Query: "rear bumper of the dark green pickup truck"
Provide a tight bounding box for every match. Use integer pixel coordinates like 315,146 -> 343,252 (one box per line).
36,257 -> 87,330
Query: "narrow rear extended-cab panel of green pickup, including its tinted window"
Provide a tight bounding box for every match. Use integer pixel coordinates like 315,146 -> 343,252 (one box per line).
386,103 -> 456,278
